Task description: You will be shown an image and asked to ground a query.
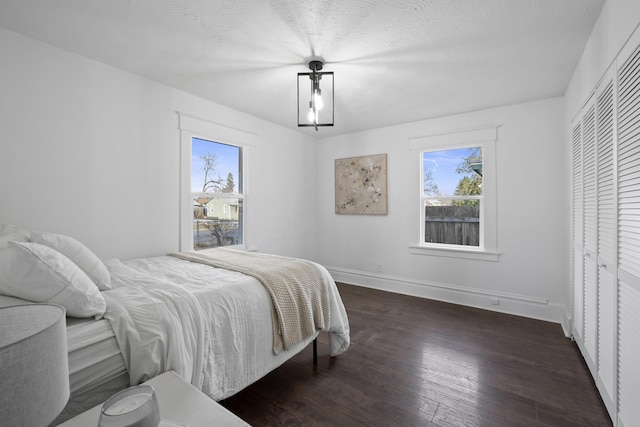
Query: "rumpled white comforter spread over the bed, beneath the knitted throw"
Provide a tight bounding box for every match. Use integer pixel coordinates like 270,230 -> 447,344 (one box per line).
102,256 -> 349,400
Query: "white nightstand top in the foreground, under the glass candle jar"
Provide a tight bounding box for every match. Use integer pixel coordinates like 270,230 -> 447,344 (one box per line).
60,371 -> 249,427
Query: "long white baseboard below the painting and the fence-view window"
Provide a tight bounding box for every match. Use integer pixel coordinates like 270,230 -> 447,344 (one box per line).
327,267 -> 571,326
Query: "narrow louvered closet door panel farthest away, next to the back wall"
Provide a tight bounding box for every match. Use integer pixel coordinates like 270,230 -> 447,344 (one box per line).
571,119 -> 584,342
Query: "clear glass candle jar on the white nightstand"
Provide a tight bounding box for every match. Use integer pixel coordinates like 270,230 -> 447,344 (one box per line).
98,384 -> 160,427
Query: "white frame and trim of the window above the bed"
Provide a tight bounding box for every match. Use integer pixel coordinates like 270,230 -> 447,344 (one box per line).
178,112 -> 256,251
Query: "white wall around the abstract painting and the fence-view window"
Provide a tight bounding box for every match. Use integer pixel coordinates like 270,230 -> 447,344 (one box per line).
318,98 -> 569,322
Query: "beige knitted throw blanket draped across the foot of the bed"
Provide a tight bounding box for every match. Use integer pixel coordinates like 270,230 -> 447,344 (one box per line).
169,248 -> 329,354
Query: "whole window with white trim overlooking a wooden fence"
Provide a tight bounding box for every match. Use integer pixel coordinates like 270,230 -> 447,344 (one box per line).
409,127 -> 498,261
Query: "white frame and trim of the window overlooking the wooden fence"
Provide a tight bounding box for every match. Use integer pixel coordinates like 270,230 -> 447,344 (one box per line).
409,126 -> 499,261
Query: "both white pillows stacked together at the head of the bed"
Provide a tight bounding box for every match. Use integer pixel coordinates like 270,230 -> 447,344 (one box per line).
0,223 -> 111,319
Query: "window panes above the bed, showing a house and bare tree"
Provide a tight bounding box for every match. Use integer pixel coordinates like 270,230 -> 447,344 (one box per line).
191,138 -> 244,250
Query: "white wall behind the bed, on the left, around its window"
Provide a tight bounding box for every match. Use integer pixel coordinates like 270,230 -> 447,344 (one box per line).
0,29 -> 316,259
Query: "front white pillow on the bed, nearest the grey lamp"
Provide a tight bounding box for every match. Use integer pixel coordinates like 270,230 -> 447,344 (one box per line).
0,241 -> 106,319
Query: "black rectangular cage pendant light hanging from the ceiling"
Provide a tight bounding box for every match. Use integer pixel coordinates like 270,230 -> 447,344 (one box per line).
298,59 -> 333,130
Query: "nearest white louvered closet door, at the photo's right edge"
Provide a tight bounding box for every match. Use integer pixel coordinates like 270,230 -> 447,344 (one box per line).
617,37 -> 640,426
